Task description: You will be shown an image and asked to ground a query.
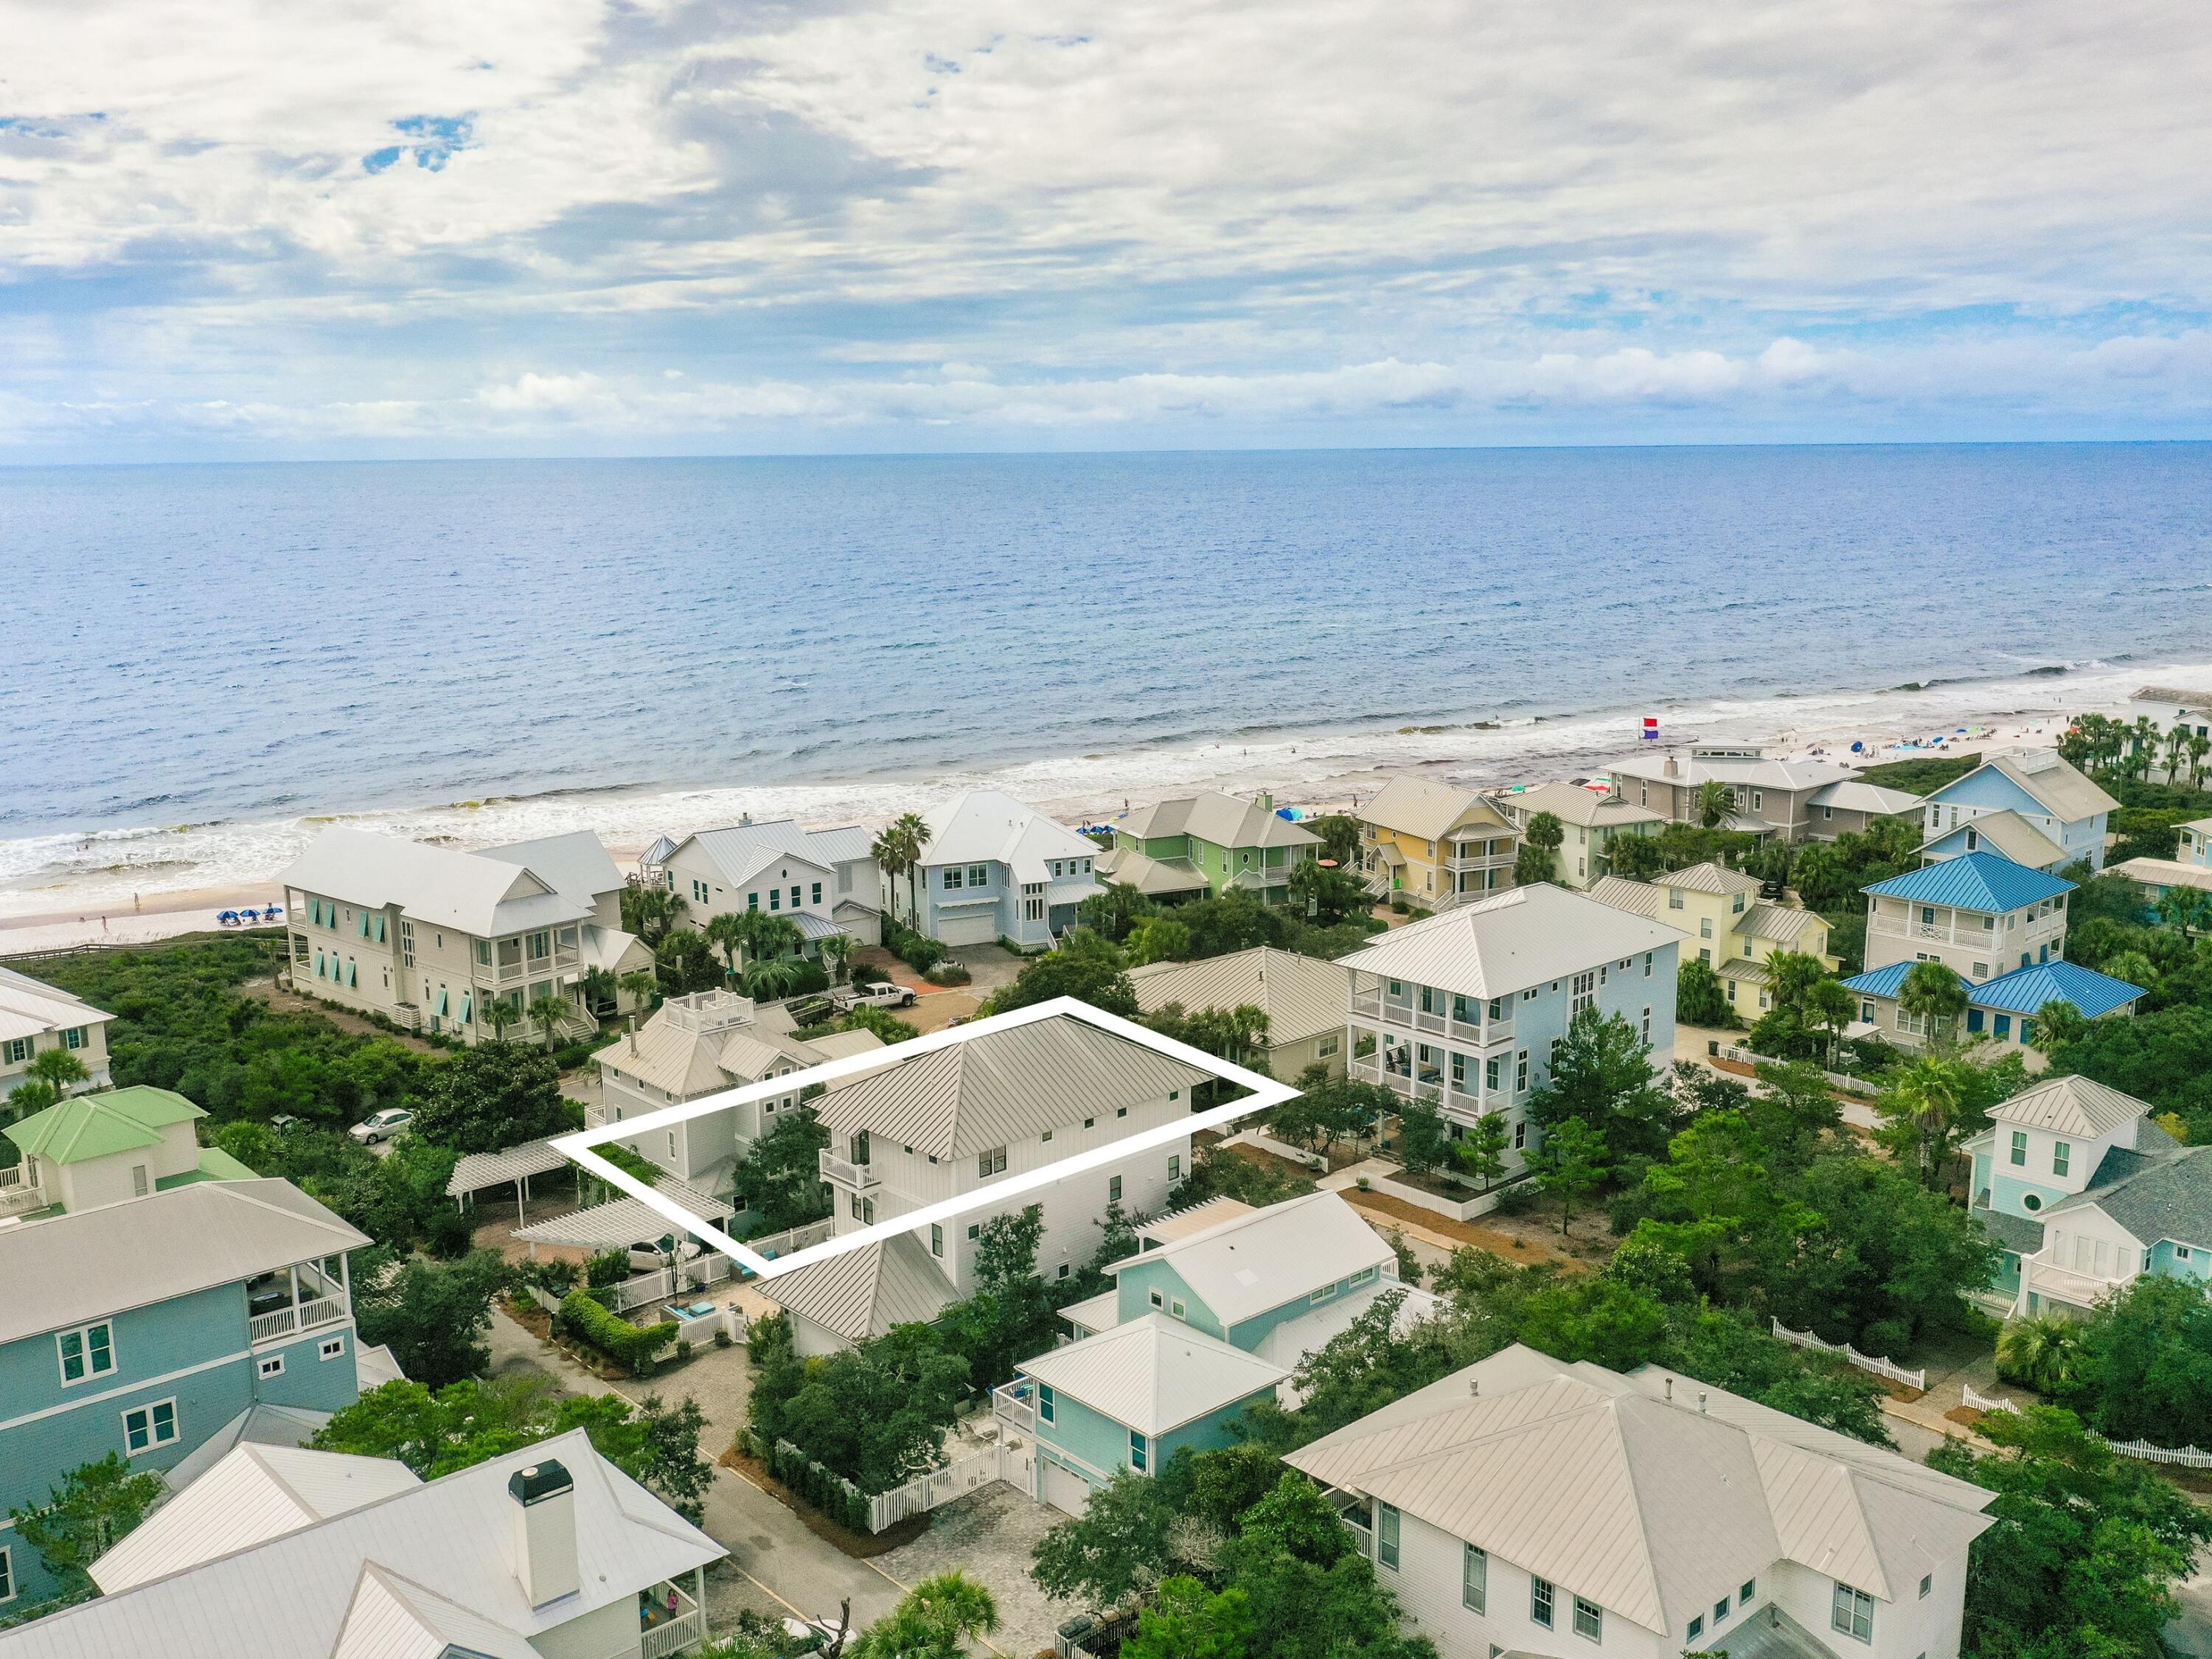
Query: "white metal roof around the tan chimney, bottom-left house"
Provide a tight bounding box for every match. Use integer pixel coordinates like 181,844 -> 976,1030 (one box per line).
0,1429 -> 726,1659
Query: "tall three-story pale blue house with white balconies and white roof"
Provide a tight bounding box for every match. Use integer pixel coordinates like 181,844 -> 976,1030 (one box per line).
1343,883 -> 1681,1170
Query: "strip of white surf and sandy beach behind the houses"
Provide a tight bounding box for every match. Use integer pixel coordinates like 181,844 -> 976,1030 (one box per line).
0,661 -> 2177,958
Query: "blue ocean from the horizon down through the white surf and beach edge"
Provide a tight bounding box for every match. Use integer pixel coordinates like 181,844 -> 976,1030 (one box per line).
0,445 -> 2212,911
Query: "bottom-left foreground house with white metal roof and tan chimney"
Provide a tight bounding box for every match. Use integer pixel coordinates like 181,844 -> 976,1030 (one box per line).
0,1429 -> 726,1659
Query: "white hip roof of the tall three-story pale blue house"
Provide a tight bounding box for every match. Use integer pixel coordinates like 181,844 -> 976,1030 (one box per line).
1338,883 -> 1681,998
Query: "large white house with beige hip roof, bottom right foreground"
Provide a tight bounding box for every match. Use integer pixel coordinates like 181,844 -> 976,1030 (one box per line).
1283,1345 -> 1993,1659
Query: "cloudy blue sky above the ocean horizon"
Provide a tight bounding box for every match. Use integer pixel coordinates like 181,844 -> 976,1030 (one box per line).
0,0 -> 2212,462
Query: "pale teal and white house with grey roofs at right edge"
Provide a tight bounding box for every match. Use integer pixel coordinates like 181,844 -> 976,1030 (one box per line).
1964,1077 -> 2212,1314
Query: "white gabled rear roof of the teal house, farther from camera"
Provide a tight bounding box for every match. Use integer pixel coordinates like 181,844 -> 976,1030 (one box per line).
1106,1192 -> 1398,1325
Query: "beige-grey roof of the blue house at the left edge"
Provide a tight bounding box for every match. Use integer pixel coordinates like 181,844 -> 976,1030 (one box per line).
0,1181 -> 369,1343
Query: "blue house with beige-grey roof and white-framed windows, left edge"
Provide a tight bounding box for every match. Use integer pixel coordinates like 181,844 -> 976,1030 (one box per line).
0,1168 -> 369,1615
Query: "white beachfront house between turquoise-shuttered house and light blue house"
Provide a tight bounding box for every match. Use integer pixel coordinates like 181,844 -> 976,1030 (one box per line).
639,818 -> 883,956
